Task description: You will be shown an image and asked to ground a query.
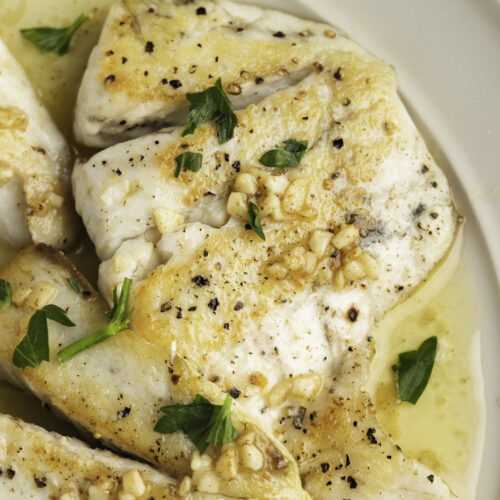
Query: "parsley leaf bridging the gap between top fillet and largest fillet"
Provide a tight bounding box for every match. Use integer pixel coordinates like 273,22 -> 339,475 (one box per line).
182,78 -> 238,144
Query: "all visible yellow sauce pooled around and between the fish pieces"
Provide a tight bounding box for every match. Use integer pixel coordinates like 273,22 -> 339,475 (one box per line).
0,0 -> 484,499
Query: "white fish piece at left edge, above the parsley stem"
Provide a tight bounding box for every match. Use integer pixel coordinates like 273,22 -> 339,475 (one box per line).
0,40 -> 80,248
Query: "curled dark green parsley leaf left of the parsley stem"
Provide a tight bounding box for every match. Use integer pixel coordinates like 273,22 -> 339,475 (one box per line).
12,304 -> 75,369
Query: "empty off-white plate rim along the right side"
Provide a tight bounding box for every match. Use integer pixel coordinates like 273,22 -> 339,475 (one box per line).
266,0 -> 500,500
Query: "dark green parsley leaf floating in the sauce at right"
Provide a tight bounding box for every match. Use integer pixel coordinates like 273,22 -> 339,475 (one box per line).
392,337 -> 437,404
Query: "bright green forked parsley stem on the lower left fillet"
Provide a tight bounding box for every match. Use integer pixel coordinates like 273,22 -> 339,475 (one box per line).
57,278 -> 134,363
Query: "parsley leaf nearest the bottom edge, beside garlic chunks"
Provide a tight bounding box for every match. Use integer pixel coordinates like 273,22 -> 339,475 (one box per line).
154,394 -> 239,453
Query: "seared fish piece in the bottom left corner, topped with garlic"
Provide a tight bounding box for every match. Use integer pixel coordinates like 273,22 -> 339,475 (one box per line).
0,415 -> 176,500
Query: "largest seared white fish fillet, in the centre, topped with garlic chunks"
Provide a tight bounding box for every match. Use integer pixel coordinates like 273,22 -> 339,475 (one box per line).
73,40 -> 457,498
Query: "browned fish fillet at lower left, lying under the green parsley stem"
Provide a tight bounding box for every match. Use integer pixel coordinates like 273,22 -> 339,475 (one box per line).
0,246 -> 307,499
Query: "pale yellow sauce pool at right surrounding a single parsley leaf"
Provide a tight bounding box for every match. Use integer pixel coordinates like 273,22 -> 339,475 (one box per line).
367,230 -> 484,500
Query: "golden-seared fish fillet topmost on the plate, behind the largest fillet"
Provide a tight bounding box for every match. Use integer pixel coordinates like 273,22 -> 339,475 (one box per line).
74,0 -> 371,147
